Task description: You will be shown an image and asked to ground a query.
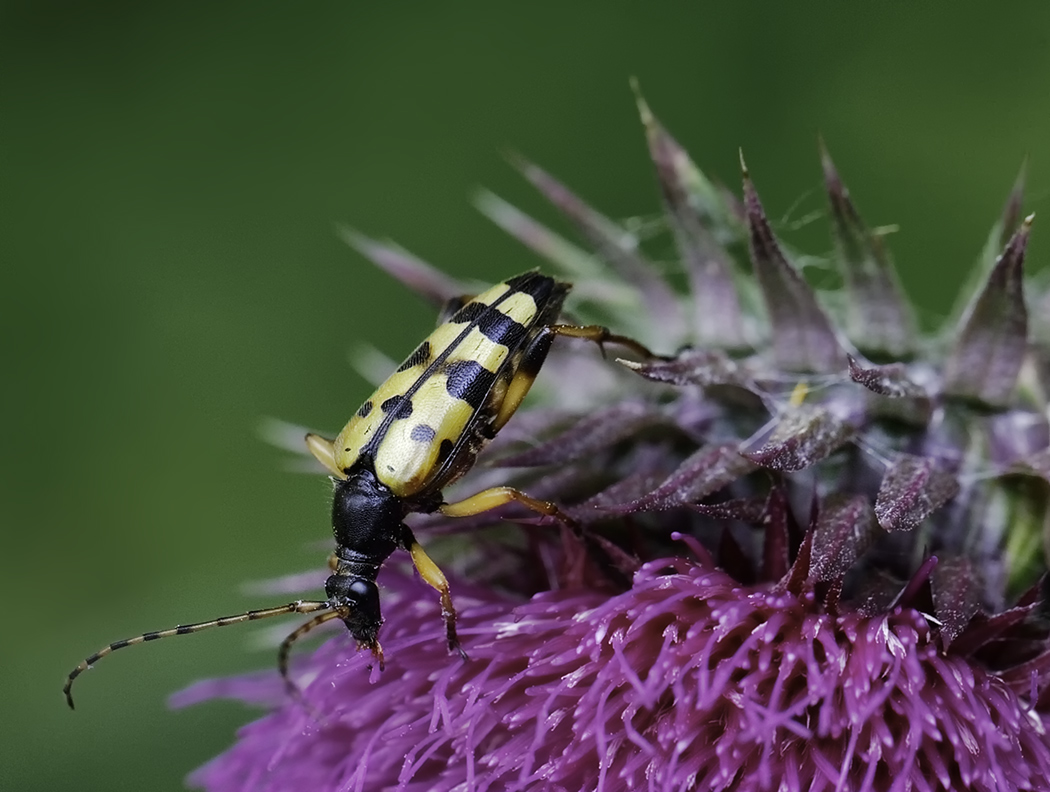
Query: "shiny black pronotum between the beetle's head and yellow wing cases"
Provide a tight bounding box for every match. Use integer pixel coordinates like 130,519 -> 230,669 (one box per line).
332,467 -> 404,565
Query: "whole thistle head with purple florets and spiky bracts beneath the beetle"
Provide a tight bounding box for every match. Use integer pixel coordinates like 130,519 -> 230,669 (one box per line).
175,99 -> 1050,792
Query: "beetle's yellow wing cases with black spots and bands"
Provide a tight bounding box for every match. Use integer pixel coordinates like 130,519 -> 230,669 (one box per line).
310,272 -> 569,498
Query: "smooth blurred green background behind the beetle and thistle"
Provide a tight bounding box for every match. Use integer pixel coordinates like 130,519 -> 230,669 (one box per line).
0,0 -> 1050,792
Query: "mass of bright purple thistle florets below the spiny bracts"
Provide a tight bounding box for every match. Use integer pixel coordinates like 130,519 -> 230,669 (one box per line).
176,558 -> 1050,792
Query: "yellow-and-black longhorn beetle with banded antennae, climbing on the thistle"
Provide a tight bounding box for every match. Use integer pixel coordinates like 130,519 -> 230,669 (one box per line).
63,271 -> 654,708
